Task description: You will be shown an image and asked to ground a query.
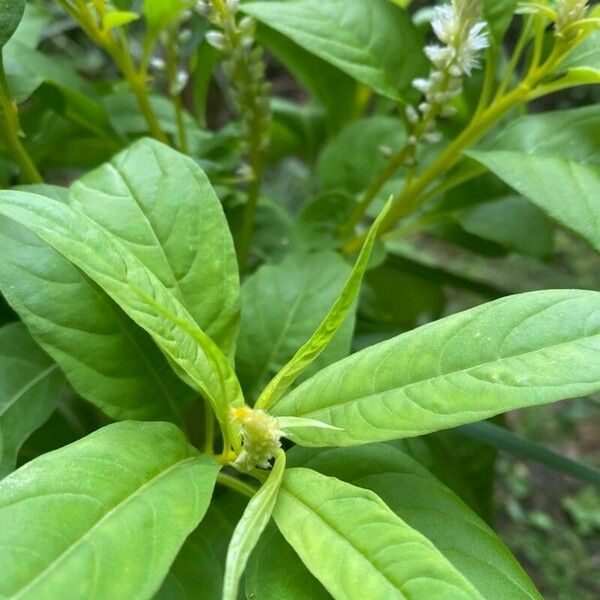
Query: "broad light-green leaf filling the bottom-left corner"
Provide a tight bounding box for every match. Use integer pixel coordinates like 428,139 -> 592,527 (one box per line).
0,422 -> 220,599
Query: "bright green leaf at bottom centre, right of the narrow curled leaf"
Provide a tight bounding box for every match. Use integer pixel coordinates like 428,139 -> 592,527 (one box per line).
273,468 -> 482,600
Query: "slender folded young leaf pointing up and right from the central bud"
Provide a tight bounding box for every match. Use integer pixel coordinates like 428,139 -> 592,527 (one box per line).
256,200 -> 391,409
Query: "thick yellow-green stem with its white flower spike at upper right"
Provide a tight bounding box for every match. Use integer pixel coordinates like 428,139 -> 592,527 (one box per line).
345,0 -> 587,252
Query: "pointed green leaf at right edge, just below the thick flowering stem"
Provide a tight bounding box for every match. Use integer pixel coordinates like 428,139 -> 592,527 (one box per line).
467,105 -> 600,250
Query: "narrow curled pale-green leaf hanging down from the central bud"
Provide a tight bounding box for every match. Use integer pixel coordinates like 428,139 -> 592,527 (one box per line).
223,450 -> 285,600
